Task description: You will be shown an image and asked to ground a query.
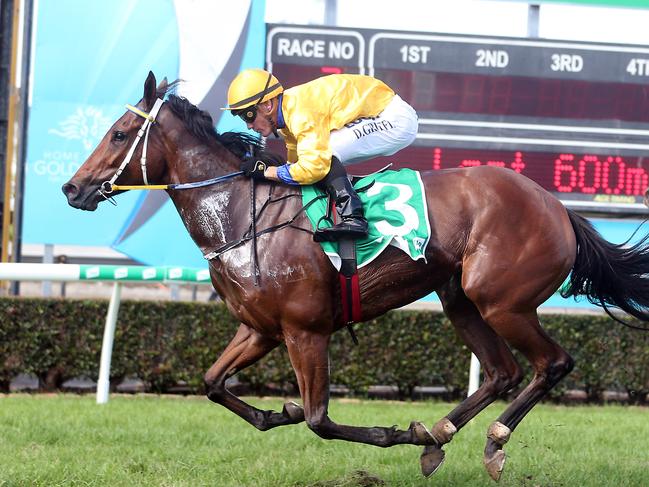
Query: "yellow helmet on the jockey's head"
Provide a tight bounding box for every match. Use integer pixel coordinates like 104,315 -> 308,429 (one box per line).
222,68 -> 284,111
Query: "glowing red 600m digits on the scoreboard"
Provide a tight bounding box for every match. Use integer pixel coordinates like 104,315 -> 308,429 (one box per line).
554,154 -> 649,196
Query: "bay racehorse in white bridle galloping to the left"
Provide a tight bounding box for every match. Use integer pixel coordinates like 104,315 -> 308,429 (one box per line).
62,73 -> 649,480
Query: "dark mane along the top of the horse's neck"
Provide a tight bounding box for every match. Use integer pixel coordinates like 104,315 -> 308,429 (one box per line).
159,80 -> 283,164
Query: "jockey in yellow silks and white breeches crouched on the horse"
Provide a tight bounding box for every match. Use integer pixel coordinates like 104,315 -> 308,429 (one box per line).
224,69 -> 418,241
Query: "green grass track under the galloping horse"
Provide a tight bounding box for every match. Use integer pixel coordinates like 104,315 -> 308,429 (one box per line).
0,395 -> 649,487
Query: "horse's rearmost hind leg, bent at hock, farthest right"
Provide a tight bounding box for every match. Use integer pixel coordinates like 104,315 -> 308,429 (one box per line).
476,308 -> 574,480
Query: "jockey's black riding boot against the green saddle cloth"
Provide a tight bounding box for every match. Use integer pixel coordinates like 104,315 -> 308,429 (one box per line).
313,157 -> 367,242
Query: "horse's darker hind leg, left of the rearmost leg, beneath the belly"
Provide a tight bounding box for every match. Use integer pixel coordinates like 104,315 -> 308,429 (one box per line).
421,278 -> 523,476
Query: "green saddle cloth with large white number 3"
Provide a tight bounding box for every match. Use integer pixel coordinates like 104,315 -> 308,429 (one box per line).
302,169 -> 430,270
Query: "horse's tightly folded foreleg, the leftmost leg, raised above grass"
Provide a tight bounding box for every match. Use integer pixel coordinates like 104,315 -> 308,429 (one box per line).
205,324 -> 304,431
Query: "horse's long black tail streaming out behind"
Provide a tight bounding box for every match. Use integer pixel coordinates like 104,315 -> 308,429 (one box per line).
561,210 -> 649,324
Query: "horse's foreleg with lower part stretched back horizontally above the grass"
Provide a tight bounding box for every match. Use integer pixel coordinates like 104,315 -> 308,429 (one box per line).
286,331 -> 435,447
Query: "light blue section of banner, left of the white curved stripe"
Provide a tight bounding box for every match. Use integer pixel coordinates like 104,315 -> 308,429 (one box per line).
22,0 -> 179,245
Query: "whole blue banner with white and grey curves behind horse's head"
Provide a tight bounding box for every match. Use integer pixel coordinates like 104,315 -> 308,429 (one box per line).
22,0 -> 265,267
